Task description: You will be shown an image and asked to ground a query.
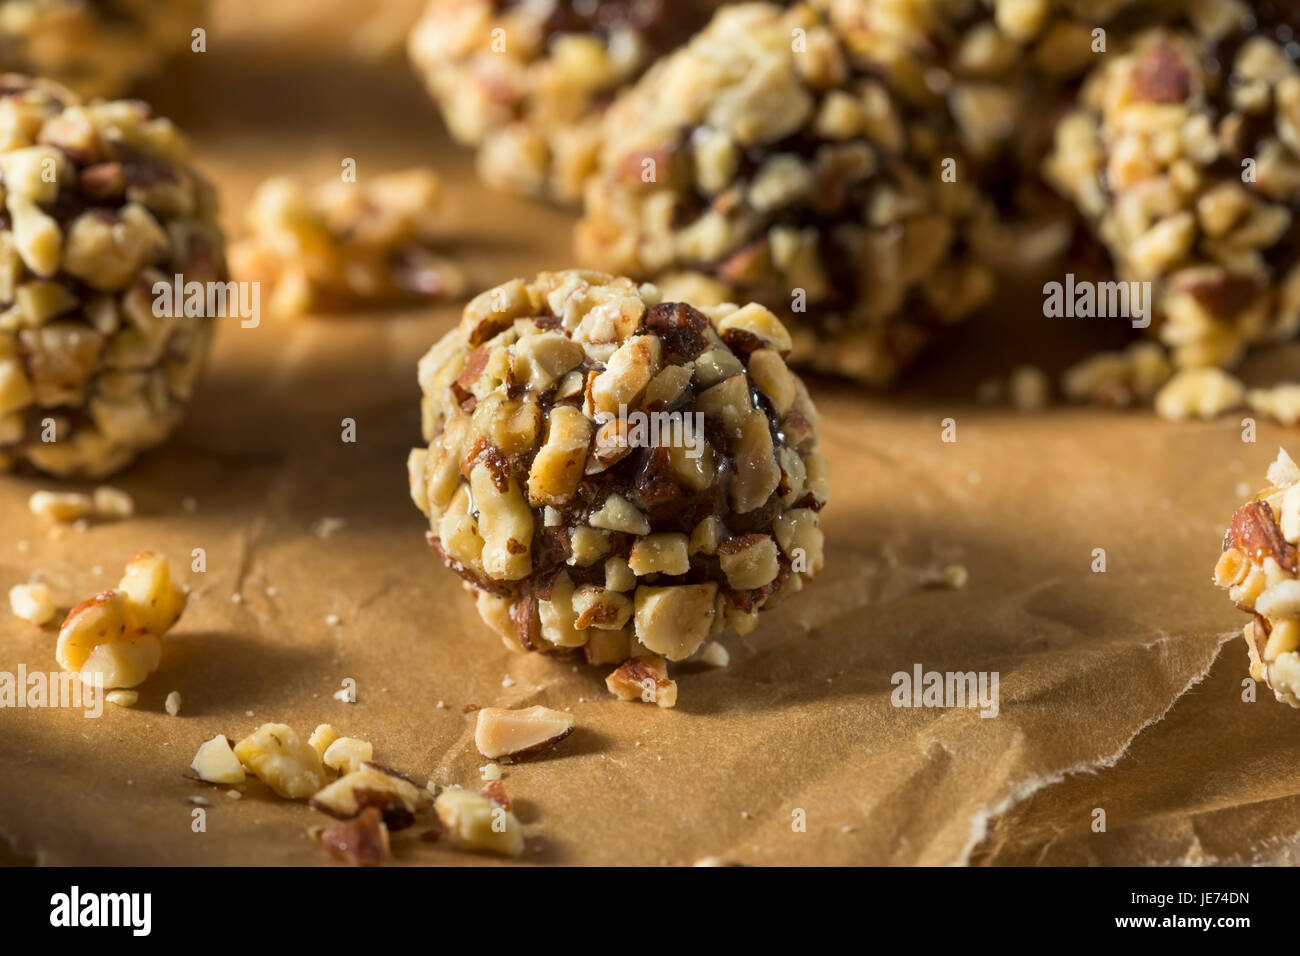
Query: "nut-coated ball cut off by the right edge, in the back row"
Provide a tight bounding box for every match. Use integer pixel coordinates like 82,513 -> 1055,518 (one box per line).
1047,7 -> 1300,368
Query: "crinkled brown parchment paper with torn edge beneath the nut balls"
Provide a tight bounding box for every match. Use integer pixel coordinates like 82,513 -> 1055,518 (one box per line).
0,0 -> 1300,865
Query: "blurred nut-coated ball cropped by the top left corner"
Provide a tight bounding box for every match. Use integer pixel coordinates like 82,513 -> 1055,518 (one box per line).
0,0 -> 207,96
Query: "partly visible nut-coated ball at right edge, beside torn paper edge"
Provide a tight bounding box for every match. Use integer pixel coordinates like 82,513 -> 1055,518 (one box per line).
1214,450 -> 1300,708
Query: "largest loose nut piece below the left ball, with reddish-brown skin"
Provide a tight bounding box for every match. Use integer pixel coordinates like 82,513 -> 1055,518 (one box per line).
55,551 -> 186,689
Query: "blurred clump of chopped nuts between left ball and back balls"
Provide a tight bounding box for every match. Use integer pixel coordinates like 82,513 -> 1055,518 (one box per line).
230,168 -> 465,316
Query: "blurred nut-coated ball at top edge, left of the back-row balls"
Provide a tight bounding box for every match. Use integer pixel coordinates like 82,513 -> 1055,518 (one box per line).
410,0 -> 722,203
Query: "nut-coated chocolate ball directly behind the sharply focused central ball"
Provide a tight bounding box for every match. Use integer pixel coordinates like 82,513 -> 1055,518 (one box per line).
576,4 -> 992,385
